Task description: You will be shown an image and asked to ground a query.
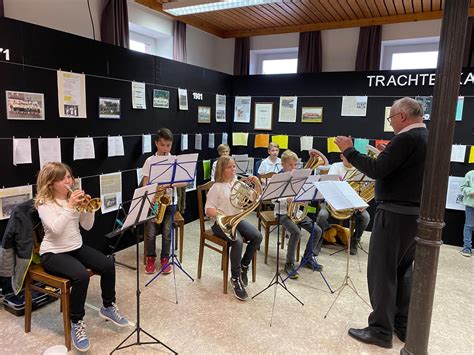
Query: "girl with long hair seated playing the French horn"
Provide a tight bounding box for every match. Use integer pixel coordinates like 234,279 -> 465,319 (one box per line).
205,156 -> 262,301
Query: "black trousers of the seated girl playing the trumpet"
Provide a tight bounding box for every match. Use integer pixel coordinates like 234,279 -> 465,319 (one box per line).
41,244 -> 115,323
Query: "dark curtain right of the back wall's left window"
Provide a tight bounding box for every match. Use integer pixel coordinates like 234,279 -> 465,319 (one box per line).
298,31 -> 323,73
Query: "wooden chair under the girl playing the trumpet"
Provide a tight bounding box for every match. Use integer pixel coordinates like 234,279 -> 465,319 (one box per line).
24,225 -> 95,350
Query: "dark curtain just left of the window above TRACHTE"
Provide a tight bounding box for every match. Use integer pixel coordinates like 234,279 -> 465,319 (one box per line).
355,26 -> 382,71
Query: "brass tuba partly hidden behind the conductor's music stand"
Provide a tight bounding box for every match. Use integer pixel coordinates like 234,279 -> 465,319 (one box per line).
328,145 -> 380,220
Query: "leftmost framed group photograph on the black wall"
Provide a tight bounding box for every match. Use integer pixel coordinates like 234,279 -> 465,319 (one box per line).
5,91 -> 44,121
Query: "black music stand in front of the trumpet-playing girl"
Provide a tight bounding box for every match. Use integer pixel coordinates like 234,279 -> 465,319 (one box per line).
107,184 -> 177,354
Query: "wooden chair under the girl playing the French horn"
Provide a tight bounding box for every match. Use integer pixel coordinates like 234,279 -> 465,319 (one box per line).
197,181 -> 257,293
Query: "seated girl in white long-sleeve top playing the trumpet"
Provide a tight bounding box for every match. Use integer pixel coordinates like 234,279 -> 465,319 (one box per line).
35,163 -> 128,351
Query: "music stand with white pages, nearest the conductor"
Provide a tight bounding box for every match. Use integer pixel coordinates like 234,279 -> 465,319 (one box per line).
315,181 -> 370,318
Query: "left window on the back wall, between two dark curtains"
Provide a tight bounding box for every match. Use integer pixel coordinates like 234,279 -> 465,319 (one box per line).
250,48 -> 298,74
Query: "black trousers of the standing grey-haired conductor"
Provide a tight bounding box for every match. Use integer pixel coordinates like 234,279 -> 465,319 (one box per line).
367,207 -> 418,340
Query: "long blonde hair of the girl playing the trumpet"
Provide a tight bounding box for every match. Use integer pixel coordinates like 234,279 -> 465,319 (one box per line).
35,162 -> 72,207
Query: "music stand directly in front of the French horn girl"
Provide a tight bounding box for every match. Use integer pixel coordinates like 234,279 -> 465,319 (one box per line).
252,169 -> 311,326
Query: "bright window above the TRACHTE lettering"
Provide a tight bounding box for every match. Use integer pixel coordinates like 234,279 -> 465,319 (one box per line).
380,37 -> 439,70
